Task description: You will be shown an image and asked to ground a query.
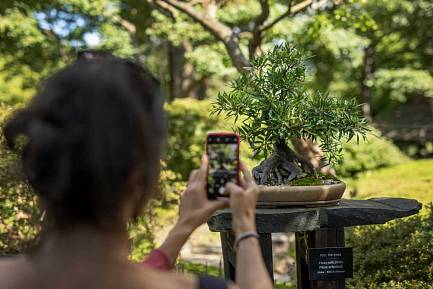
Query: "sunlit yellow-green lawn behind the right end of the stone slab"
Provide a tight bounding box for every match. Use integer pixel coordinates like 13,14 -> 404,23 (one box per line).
353,159 -> 433,205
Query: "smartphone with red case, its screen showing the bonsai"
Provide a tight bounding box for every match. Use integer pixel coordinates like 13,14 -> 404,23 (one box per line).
206,132 -> 239,200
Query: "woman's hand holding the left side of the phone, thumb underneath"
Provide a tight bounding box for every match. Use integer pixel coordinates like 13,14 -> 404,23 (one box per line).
179,155 -> 229,230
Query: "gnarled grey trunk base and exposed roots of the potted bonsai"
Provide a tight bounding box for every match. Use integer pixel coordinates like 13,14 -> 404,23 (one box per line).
253,140 -> 316,185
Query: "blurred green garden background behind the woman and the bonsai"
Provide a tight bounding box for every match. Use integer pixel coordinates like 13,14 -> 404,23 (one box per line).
0,0 -> 433,289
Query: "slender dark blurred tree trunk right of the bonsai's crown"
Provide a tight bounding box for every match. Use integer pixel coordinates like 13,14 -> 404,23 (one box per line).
359,42 -> 375,121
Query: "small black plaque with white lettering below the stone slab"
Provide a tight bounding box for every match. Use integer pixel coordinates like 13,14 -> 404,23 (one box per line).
308,247 -> 353,280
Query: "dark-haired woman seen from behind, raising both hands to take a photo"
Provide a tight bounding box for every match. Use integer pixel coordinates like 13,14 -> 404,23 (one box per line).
0,57 -> 272,289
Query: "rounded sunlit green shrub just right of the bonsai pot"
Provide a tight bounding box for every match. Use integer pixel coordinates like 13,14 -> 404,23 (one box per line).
337,130 -> 409,177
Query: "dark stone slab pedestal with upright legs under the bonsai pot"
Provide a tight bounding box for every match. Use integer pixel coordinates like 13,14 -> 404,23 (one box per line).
208,198 -> 421,289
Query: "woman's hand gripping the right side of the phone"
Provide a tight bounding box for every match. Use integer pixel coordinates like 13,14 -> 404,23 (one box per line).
226,162 -> 260,236
